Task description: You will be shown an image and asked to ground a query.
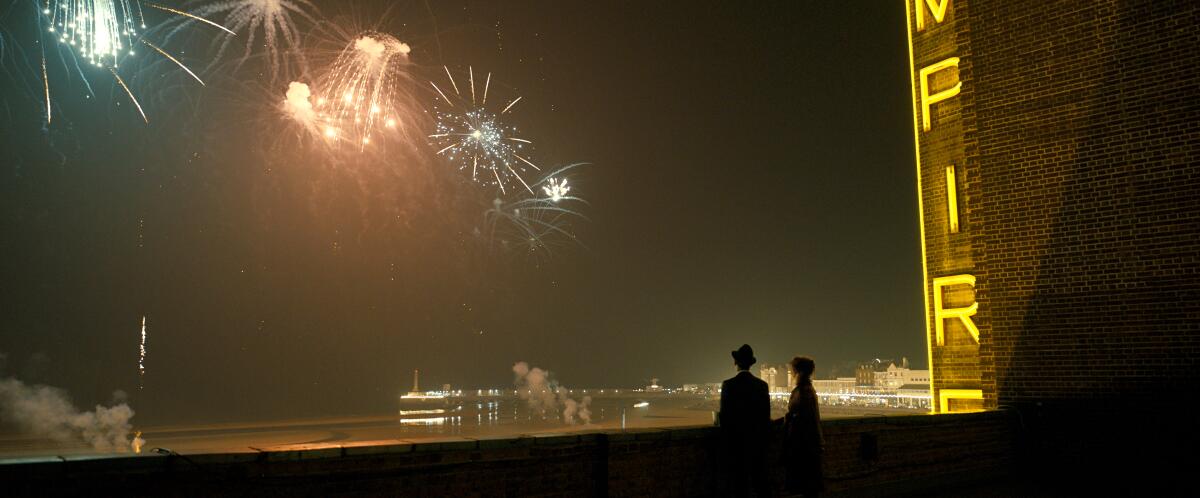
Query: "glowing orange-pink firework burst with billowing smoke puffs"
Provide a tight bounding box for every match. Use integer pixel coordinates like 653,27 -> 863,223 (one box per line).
283,31 -> 418,151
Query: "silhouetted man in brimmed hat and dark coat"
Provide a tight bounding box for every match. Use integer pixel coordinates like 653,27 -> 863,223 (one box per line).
716,344 -> 770,497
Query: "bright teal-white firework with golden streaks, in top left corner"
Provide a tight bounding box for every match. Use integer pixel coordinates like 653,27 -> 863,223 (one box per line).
40,0 -> 233,124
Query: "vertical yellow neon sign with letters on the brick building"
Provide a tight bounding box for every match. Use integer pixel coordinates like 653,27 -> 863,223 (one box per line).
905,0 -> 988,413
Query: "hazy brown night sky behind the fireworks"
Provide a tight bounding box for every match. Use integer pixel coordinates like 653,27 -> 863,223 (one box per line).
0,0 -> 925,421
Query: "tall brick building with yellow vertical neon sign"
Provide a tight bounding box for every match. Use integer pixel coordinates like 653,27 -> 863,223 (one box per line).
906,0 -> 1200,492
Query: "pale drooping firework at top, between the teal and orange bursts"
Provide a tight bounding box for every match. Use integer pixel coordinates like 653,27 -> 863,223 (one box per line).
168,0 -> 318,80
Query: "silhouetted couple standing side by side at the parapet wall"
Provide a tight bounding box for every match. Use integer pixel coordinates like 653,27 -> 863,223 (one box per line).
718,344 -> 824,497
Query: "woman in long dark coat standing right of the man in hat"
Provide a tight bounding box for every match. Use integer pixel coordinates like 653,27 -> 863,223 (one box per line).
784,356 -> 824,497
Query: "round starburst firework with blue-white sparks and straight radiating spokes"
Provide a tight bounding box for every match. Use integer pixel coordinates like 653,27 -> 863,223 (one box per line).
430,66 -> 541,194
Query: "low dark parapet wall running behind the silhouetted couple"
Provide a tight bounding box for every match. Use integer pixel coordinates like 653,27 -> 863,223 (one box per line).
0,412 -> 1018,497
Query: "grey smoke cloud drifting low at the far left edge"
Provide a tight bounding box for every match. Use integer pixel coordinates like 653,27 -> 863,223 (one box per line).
0,378 -> 133,451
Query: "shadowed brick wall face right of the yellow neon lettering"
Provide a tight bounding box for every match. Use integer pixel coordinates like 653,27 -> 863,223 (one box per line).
967,0 -> 1200,404
